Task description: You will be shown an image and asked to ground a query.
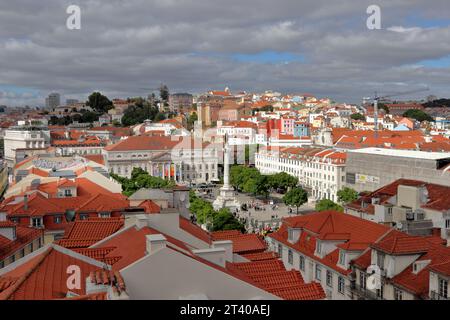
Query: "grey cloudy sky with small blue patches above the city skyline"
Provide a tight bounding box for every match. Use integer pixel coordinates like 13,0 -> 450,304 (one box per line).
0,0 -> 450,106
